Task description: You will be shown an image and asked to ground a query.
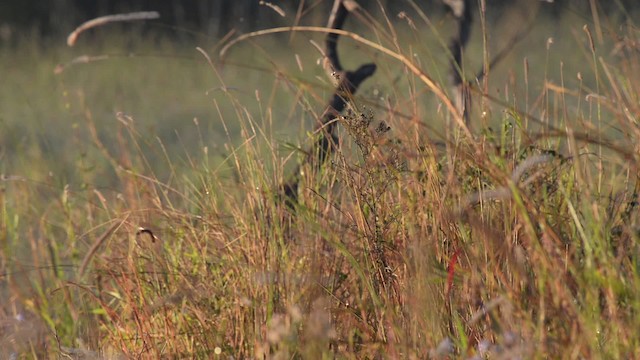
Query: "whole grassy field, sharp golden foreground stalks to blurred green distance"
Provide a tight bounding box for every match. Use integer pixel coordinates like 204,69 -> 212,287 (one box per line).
0,1 -> 640,359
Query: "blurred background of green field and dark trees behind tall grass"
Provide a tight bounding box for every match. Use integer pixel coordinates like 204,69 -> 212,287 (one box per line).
0,0 -> 638,186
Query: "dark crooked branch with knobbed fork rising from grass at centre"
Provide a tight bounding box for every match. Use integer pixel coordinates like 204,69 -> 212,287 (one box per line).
281,0 -> 376,206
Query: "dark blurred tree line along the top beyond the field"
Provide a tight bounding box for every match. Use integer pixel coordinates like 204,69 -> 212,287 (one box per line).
0,0 -> 640,39
